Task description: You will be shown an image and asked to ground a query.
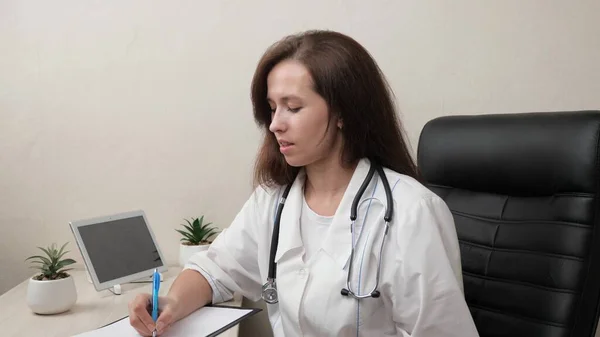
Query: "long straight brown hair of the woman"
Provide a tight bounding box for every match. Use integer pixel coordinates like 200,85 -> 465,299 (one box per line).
251,30 -> 418,186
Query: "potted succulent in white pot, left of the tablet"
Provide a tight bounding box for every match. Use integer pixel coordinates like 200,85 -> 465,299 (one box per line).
25,243 -> 77,315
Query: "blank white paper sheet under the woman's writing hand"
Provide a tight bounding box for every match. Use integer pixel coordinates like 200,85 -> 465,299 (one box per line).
73,306 -> 252,337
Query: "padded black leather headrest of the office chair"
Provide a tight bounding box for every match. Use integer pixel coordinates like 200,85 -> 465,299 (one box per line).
418,111 -> 600,196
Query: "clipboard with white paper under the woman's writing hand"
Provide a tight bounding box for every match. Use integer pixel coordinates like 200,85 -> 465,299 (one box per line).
72,304 -> 262,337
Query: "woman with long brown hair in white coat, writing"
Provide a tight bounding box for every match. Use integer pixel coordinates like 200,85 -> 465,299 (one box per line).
129,31 -> 478,337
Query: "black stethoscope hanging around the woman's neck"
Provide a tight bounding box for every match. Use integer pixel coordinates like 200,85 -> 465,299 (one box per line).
262,163 -> 393,304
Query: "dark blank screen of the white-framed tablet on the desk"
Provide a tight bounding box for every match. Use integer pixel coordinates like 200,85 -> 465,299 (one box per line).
79,216 -> 163,283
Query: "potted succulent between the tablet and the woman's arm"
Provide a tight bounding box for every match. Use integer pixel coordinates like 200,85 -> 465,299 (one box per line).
176,216 -> 218,267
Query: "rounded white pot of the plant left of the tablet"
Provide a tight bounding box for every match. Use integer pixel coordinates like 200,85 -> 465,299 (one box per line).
27,276 -> 77,315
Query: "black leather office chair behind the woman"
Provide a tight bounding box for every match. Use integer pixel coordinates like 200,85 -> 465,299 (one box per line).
418,111 -> 600,337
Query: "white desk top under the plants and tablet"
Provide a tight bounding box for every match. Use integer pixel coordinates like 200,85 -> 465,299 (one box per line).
0,267 -> 242,337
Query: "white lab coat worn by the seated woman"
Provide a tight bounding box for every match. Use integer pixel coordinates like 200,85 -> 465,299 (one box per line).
187,159 -> 478,337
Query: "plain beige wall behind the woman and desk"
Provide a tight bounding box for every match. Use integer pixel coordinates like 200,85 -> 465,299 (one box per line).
0,0 -> 600,335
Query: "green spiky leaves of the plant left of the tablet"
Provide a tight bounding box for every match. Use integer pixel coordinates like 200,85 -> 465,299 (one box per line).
25,242 -> 75,281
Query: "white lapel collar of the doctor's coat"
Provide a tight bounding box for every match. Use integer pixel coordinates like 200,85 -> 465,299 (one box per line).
275,158 -> 375,269
